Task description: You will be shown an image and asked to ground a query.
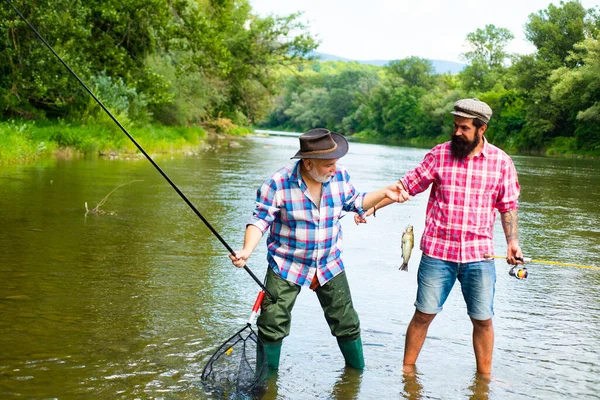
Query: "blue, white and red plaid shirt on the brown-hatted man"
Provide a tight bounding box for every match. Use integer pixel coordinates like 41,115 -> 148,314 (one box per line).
248,161 -> 366,286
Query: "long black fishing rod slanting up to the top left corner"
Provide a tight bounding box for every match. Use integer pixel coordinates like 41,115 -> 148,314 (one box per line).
6,0 -> 276,301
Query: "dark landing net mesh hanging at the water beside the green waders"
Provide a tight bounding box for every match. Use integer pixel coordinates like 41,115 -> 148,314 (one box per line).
201,324 -> 267,400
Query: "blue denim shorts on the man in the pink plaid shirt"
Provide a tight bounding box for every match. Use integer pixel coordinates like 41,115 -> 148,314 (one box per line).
415,254 -> 496,320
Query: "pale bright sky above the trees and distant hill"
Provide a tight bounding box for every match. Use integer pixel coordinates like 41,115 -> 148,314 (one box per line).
250,0 -> 600,62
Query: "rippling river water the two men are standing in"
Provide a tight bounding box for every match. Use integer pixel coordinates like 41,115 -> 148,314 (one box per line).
0,136 -> 600,399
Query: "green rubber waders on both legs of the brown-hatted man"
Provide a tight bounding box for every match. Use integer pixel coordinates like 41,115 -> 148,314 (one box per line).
257,268 -> 365,369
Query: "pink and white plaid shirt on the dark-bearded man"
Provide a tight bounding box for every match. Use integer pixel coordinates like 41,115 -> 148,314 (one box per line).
401,138 -> 520,263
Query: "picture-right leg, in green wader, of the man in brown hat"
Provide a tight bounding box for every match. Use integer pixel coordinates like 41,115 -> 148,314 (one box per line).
315,272 -> 365,369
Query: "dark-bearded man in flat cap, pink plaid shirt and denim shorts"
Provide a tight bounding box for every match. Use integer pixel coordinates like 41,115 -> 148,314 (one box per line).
364,99 -> 523,376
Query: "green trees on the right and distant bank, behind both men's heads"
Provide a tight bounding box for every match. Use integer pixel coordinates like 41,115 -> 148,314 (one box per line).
263,1 -> 600,154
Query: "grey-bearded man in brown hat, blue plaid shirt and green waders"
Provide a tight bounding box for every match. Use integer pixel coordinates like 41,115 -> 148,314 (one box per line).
230,129 -> 408,369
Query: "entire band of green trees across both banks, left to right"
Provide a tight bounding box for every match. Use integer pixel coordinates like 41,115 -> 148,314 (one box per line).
0,0 -> 600,154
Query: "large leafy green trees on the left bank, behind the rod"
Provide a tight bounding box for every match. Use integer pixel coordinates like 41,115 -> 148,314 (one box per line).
0,0 -> 316,126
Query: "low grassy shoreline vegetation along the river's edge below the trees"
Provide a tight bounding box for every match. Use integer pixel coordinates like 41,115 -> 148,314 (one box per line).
0,120 -> 600,166
